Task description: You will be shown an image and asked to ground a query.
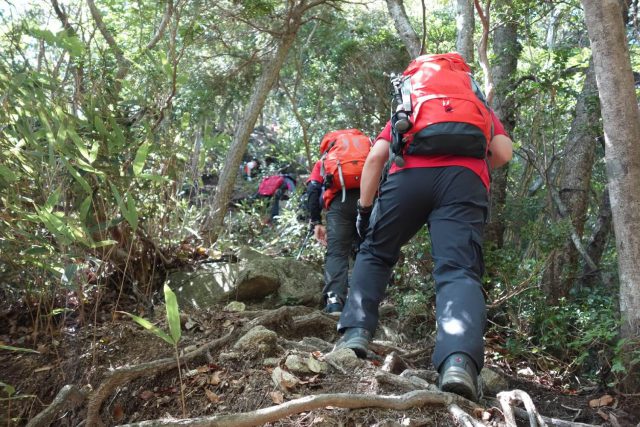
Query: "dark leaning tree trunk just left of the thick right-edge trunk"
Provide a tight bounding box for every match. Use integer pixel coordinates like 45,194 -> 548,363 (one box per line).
543,64 -> 600,304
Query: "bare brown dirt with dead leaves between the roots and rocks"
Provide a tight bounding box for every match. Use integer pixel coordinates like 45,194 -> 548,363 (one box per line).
0,300 -> 640,427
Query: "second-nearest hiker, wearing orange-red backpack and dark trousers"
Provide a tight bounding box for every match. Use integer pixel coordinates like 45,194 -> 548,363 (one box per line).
307,129 -> 371,315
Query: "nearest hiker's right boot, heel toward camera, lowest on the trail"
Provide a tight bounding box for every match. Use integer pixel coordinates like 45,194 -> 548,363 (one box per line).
439,353 -> 478,402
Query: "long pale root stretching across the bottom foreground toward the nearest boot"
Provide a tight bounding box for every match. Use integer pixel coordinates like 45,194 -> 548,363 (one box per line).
115,390 -> 460,427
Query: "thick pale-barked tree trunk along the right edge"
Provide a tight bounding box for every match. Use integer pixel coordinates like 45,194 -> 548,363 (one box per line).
582,0 -> 640,393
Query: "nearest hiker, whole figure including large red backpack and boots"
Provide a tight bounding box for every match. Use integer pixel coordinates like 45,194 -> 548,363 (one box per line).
336,53 -> 512,400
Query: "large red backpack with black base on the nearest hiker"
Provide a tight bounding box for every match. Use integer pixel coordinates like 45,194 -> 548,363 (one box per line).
402,53 -> 493,158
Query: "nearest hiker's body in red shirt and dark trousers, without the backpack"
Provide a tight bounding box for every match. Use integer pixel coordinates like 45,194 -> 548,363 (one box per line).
335,97 -> 512,400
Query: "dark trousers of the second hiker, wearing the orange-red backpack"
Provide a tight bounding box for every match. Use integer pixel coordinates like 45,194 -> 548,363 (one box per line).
322,189 -> 360,302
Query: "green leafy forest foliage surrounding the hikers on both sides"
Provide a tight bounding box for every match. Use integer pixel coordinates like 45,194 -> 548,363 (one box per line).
0,0 -> 640,396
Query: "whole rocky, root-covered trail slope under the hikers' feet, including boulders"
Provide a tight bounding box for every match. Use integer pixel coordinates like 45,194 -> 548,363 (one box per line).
0,251 -> 640,427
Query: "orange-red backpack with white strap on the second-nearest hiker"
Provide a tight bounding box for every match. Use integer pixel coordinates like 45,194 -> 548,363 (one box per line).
320,129 -> 371,204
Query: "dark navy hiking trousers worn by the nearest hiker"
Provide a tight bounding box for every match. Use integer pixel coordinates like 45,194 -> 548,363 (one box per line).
338,166 -> 488,370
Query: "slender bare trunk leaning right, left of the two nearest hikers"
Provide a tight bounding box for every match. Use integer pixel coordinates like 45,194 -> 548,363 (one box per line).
206,2 -> 307,243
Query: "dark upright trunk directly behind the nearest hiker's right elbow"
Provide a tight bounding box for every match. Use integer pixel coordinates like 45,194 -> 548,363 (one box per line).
485,0 -> 521,248
